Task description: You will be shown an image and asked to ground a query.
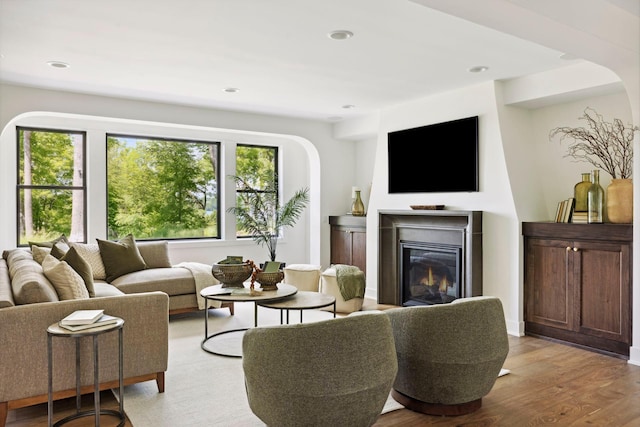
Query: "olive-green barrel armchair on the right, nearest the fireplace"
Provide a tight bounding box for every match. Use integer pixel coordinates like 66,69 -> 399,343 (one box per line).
384,297 -> 509,415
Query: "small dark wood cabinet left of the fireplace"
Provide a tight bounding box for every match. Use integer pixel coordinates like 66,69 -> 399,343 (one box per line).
329,215 -> 367,273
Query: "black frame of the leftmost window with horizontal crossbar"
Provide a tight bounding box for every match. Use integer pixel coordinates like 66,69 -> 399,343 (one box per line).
16,125 -> 88,247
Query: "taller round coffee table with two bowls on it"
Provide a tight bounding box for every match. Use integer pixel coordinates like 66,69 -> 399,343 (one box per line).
200,283 -> 298,357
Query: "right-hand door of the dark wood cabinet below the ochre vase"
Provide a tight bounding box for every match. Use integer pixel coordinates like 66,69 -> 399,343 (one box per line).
573,242 -> 631,344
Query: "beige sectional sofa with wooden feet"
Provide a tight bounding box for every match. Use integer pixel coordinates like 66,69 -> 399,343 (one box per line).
0,242 -> 228,427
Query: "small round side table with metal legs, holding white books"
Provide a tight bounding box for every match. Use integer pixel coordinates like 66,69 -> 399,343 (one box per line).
47,318 -> 126,427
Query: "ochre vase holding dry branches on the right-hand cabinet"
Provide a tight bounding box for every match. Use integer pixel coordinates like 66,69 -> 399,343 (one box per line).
549,107 -> 638,223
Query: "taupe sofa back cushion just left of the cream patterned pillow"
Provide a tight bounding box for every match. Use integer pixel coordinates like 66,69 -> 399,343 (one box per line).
4,249 -> 60,305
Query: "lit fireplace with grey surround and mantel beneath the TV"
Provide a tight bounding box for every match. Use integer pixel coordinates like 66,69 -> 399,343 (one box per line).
378,210 -> 482,306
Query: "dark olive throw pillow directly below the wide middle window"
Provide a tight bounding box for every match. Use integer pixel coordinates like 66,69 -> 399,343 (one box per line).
96,234 -> 147,282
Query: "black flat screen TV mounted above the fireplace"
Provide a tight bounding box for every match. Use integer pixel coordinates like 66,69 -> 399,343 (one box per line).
388,116 -> 479,194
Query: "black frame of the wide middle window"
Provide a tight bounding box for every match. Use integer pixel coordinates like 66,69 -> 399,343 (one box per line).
104,131 -> 224,242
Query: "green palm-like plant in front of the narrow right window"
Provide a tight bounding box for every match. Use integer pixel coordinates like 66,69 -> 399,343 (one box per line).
227,176 -> 309,261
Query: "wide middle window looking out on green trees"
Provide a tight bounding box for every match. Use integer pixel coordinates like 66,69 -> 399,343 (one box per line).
107,134 -> 220,240
